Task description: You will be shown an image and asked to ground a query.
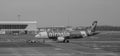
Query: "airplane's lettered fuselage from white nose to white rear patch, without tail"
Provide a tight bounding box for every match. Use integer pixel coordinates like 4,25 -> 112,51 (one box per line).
35,31 -> 88,38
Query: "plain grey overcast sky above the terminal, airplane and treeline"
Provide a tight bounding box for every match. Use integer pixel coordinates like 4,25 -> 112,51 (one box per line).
0,0 -> 120,26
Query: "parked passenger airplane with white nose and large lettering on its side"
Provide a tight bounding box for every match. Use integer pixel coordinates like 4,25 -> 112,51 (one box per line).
30,21 -> 97,43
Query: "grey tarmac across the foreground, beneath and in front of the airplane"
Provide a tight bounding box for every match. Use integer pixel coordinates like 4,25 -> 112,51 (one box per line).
0,31 -> 120,56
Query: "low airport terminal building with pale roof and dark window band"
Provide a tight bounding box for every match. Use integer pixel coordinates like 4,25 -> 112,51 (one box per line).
0,21 -> 37,34
